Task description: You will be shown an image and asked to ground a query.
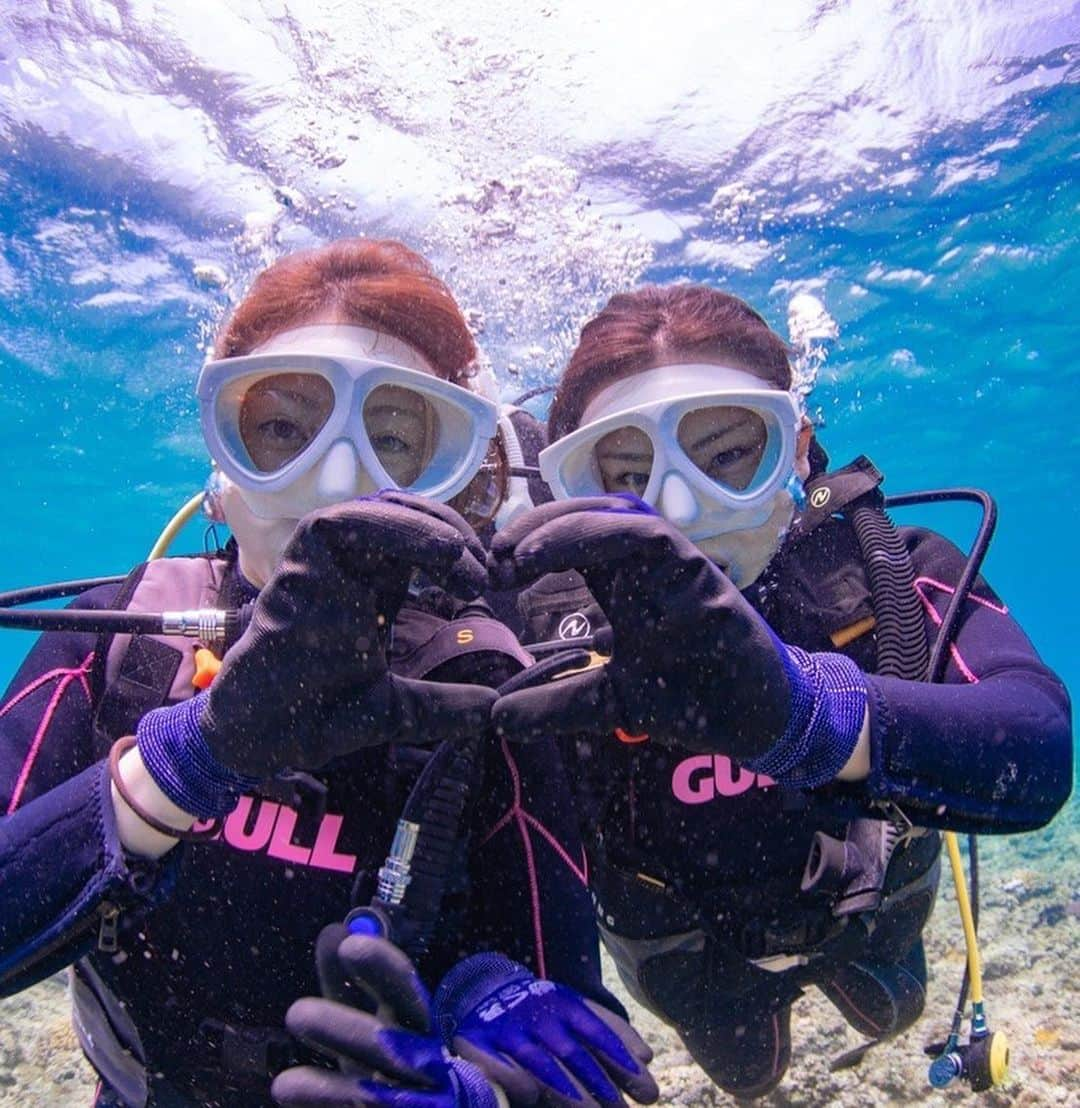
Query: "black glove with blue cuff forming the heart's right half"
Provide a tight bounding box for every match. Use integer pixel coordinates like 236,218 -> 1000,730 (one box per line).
488,494 -> 867,788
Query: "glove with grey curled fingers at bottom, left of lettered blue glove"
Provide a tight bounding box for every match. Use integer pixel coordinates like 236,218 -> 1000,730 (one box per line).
271,924 -> 505,1108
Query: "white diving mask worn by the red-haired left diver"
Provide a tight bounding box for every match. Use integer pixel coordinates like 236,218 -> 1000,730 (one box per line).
196,324 -> 498,519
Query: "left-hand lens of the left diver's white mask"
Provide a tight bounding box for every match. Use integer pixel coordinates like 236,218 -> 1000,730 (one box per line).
237,373 -> 333,473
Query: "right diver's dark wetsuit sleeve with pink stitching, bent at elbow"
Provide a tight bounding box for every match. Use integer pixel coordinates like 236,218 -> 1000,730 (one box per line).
864,531 -> 1072,833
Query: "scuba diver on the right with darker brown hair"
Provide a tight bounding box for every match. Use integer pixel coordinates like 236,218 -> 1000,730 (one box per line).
478,285 -> 1072,1098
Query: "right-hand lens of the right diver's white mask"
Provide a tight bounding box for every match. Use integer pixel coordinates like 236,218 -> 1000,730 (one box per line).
677,406 -> 774,492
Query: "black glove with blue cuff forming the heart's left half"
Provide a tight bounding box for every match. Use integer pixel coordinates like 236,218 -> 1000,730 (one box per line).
136,492 -> 494,819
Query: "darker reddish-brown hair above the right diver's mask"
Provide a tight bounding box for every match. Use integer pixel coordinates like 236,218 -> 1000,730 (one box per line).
547,285 -> 791,442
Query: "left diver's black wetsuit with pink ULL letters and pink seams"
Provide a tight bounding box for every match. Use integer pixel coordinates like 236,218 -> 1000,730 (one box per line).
0,562 -> 618,1108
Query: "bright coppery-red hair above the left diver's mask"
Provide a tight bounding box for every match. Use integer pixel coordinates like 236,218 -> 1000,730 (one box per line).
214,238 -> 476,384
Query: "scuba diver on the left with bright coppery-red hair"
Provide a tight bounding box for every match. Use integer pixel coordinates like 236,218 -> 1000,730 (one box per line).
0,239 -> 656,1108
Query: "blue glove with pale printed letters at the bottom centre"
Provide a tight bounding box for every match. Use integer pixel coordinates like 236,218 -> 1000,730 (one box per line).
434,954 -> 660,1108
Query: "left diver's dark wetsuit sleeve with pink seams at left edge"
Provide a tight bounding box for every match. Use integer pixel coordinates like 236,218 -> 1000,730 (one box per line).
0,591 -> 176,995
